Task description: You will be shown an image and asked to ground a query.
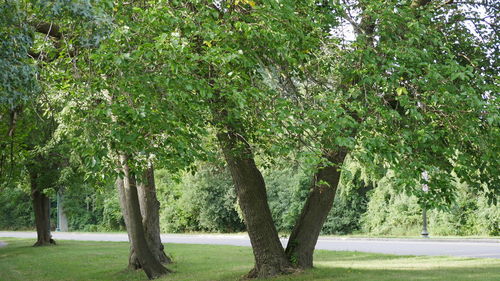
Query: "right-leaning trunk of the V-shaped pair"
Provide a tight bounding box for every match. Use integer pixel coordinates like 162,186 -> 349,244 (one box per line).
285,152 -> 346,268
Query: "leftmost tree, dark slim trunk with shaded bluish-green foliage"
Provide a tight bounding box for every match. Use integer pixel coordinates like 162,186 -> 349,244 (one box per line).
0,2 -> 60,246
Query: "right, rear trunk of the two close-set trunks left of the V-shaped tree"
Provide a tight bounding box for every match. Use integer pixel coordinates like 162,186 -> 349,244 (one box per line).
138,164 -> 172,263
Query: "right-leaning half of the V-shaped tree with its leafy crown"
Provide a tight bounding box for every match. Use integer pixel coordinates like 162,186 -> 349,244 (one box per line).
280,1 -> 498,268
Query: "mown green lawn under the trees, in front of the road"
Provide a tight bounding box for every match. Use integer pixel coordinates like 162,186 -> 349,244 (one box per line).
0,238 -> 500,281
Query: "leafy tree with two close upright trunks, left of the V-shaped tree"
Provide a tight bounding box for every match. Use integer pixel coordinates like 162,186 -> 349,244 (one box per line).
60,3 -> 204,278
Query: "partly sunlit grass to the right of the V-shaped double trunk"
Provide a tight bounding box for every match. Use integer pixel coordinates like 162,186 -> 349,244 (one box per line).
273,251 -> 500,281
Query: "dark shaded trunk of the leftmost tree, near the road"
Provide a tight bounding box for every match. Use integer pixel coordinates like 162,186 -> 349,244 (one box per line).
30,174 -> 56,246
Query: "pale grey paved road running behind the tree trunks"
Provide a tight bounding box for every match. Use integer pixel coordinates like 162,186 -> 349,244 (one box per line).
0,231 -> 500,258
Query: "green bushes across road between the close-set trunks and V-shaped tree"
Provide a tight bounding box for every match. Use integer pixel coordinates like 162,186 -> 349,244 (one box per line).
156,164 -> 245,232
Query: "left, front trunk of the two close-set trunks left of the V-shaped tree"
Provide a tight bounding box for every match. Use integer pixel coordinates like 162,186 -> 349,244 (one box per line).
120,155 -> 169,279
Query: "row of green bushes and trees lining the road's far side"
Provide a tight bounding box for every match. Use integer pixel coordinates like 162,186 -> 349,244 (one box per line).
0,158 -> 500,236
